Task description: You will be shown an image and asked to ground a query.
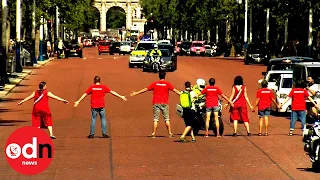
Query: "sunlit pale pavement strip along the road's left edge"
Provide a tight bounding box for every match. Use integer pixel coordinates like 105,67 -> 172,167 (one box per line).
0,58 -> 54,100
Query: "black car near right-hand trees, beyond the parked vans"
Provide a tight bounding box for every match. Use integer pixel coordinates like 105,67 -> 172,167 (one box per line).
244,43 -> 271,65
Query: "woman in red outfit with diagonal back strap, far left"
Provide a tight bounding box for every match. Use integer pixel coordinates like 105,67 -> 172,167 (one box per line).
18,82 -> 69,139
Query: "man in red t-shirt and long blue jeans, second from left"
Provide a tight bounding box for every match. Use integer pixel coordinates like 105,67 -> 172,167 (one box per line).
74,76 -> 127,139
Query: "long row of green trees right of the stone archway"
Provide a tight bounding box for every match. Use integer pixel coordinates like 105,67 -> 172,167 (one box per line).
140,0 -> 320,43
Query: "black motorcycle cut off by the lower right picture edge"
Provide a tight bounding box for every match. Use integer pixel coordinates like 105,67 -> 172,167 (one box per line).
303,120 -> 320,172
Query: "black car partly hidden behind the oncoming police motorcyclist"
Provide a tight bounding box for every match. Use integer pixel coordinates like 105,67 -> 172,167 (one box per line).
142,49 -> 177,72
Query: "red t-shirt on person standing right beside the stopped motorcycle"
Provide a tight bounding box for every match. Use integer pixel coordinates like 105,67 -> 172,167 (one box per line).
201,86 -> 223,108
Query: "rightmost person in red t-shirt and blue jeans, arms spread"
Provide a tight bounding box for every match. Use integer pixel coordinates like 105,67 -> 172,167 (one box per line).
279,80 -> 318,136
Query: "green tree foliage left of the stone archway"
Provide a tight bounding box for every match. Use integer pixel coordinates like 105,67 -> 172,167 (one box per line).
1,0 -> 99,37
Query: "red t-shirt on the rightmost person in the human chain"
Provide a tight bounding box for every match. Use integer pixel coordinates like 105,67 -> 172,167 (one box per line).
289,88 -> 309,111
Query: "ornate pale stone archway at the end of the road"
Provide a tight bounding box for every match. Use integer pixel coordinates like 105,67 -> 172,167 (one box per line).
93,0 -> 146,32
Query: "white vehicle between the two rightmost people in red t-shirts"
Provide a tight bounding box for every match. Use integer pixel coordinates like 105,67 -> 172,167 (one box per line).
272,73 -> 293,112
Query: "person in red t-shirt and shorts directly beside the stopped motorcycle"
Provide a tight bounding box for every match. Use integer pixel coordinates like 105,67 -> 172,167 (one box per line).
201,78 -> 233,137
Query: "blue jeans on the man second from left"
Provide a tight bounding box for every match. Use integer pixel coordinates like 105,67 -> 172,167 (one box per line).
90,108 -> 107,135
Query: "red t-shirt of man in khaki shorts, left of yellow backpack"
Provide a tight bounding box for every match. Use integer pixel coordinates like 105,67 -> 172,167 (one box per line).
147,80 -> 174,104
